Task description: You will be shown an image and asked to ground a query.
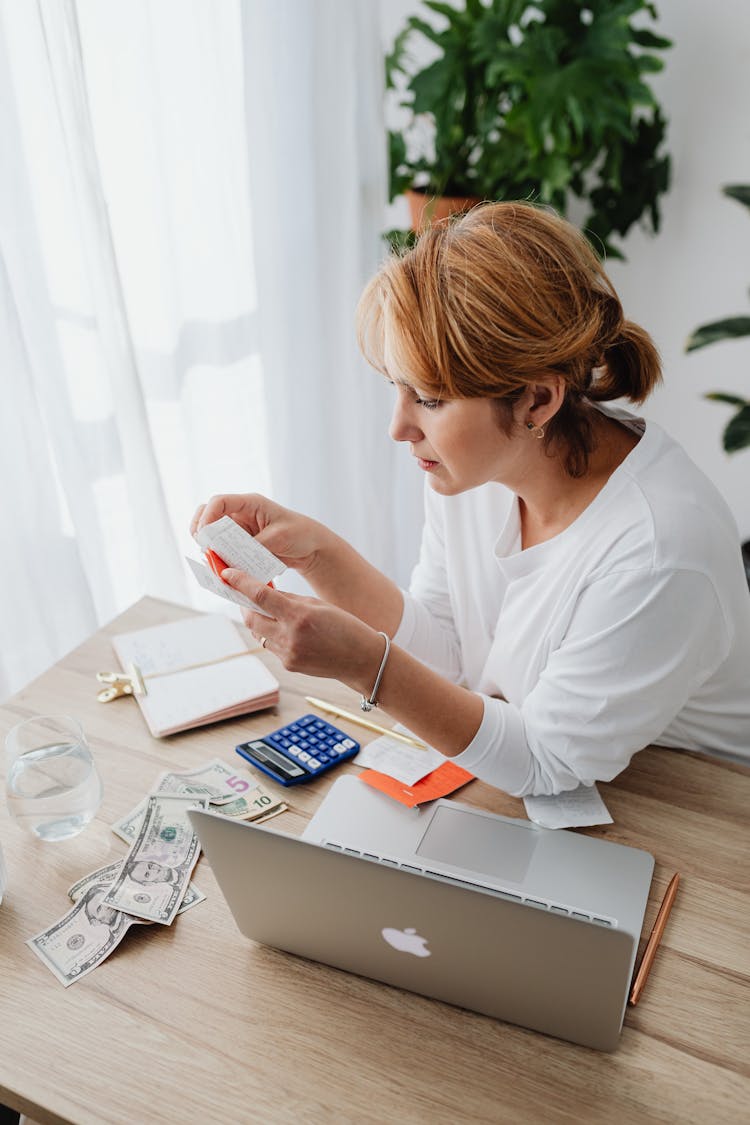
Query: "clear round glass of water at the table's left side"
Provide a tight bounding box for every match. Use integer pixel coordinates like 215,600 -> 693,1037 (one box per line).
6,716 -> 101,840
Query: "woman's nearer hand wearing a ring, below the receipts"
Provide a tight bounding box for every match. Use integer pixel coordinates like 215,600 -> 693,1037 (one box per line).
222,567 -> 383,692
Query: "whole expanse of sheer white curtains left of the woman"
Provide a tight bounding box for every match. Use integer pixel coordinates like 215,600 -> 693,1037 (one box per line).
0,0 -> 418,696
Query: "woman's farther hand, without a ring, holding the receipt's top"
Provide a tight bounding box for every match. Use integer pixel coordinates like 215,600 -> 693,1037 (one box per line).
190,493 -> 333,574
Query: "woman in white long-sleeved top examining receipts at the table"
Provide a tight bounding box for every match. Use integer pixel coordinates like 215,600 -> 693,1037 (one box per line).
192,204 -> 750,795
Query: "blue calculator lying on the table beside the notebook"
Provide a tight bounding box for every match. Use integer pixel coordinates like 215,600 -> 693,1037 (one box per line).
235,714 -> 360,785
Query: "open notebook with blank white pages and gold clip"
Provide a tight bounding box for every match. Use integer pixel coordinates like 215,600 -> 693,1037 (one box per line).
112,614 -> 279,738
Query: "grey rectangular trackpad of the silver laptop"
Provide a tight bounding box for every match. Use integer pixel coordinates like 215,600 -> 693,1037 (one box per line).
416,804 -> 537,883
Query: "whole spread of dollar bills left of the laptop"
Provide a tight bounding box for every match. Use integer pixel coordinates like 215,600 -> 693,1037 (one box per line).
26,758 -> 287,987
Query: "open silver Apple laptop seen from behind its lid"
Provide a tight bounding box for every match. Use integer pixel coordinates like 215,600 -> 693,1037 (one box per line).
188,775 -> 653,1051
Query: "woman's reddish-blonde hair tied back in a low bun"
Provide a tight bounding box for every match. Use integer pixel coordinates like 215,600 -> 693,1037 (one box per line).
356,203 -> 661,476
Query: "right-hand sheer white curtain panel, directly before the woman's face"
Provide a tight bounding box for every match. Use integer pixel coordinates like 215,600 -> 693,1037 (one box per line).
243,0 -> 421,578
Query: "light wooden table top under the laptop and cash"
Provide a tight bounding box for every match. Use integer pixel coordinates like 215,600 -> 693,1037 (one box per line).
0,599 -> 750,1125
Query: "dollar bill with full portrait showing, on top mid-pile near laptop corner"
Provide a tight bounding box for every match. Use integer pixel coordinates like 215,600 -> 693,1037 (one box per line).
105,793 -> 208,926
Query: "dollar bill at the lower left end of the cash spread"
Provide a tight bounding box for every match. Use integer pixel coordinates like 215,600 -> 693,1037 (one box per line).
26,882 -> 144,988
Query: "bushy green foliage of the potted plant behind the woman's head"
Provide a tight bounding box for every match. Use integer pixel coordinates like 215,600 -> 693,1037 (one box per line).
386,0 -> 671,258
